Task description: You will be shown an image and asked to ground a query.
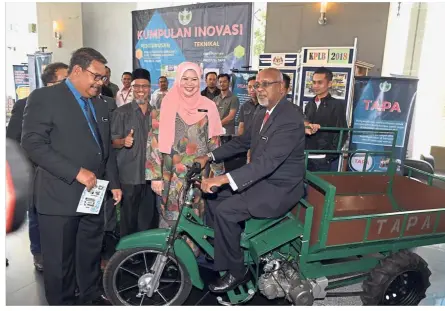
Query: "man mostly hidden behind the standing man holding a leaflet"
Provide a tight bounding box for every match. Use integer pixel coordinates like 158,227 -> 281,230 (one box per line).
6,63 -> 68,272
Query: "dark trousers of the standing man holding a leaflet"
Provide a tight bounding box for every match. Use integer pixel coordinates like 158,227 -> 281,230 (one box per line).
38,211 -> 104,305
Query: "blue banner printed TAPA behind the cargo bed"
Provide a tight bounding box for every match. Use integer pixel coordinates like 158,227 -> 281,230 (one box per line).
349,77 -> 418,172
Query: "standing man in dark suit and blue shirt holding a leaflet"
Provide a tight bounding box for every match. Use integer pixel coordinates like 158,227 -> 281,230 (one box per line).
22,48 -> 122,305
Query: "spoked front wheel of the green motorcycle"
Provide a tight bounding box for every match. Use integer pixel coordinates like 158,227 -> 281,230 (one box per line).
103,248 -> 192,306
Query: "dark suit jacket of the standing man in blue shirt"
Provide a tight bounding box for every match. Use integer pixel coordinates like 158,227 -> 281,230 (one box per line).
22,82 -> 120,216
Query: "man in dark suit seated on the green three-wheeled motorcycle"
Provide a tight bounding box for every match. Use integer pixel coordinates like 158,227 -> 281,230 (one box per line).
196,68 -> 305,293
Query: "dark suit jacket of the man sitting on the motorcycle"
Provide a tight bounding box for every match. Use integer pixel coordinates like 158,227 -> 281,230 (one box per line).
213,99 -> 305,218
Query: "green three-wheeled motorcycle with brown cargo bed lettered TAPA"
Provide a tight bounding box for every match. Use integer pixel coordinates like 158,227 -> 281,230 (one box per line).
103,128 -> 445,305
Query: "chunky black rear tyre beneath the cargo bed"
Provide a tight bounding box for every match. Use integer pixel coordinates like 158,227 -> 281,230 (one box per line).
361,250 -> 431,306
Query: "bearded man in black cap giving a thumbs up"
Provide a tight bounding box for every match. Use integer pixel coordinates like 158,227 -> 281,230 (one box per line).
111,68 -> 156,244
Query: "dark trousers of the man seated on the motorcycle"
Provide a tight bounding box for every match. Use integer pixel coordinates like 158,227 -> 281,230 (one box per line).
206,185 -> 252,278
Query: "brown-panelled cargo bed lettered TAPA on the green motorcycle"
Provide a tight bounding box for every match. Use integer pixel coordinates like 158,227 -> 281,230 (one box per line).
299,174 -> 445,250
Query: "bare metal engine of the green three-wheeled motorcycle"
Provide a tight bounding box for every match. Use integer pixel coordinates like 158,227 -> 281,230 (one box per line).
258,259 -> 314,306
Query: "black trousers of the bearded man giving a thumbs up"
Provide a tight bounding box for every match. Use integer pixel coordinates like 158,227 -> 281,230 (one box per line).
120,182 -> 159,237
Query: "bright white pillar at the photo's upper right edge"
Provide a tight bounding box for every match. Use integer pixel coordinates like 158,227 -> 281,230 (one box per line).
413,2 -> 445,157
